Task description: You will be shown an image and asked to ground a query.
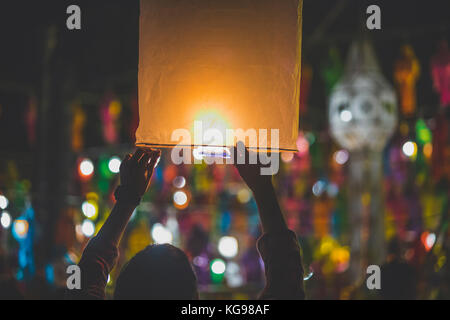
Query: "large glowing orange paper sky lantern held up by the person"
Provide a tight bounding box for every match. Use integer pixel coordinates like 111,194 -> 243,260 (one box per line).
136,0 -> 302,155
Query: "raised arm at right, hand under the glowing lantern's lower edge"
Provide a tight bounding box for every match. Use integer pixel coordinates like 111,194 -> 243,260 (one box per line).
233,142 -> 305,299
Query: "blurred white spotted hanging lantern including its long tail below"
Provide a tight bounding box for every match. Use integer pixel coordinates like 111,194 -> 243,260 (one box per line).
328,40 -> 397,283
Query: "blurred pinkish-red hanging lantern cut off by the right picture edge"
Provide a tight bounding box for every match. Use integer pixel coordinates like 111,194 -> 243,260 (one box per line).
431,41 -> 450,107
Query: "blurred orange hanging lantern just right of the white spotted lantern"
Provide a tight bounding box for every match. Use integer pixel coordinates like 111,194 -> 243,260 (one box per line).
394,46 -> 420,116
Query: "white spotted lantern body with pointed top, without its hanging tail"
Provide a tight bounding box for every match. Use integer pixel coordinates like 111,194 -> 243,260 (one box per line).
328,41 -> 397,151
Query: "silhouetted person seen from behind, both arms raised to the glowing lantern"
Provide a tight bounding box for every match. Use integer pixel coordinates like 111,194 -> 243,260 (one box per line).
66,143 -> 304,300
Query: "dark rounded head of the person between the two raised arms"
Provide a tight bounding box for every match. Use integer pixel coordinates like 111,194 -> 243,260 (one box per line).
114,244 -> 198,300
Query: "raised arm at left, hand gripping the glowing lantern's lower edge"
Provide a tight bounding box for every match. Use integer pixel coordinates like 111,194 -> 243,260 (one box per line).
66,149 -> 160,299
